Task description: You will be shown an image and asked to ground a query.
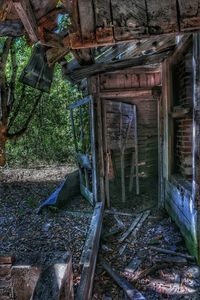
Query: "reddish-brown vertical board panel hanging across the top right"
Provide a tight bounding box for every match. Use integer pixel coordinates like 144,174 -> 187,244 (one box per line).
70,0 -> 200,48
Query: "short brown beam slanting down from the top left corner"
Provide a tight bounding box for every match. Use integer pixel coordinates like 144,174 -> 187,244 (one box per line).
13,0 -> 39,43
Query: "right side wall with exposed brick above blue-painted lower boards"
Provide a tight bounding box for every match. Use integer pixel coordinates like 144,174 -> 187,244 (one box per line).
162,38 -> 198,257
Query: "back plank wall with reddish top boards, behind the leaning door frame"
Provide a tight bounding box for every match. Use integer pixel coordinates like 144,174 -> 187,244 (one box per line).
93,68 -> 161,205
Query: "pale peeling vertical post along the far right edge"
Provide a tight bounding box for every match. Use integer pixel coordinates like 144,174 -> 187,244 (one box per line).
192,33 -> 200,263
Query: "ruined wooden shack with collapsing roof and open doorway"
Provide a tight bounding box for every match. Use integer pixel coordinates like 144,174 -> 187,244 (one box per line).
0,0 -> 200,299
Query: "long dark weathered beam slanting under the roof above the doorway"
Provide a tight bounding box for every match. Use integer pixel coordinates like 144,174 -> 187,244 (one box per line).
65,49 -> 172,83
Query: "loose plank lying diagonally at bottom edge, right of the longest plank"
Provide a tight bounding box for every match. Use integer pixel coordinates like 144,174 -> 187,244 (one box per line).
100,259 -> 146,300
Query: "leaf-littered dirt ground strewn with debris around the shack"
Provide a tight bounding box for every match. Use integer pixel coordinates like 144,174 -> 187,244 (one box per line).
0,166 -> 200,300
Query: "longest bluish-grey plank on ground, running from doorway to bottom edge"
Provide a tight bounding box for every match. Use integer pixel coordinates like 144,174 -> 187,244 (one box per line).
77,202 -> 104,300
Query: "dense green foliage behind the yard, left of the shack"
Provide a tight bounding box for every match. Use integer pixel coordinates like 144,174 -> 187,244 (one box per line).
6,38 -> 81,166
